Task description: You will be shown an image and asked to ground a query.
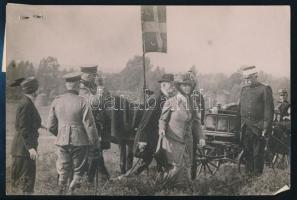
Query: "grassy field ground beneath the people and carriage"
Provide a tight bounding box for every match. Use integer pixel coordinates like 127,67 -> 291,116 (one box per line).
6,103 -> 290,196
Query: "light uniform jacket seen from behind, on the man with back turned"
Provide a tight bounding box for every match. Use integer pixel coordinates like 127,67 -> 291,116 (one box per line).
48,90 -> 100,146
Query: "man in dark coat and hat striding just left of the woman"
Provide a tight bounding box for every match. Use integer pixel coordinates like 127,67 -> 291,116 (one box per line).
134,74 -> 174,175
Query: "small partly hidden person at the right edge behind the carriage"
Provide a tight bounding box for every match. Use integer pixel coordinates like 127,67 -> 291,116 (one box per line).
277,89 -> 291,121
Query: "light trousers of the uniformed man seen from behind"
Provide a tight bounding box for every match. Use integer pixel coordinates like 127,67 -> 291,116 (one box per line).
56,145 -> 89,186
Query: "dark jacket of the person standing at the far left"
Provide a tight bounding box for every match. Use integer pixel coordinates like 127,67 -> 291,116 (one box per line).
11,96 -> 41,157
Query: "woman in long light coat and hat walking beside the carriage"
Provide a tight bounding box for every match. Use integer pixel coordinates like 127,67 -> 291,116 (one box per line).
159,74 -> 205,188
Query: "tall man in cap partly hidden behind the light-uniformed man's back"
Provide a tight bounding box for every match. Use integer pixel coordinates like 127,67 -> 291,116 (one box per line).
79,66 -> 110,185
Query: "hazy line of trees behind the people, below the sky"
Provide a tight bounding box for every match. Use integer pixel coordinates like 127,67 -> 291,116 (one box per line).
6,55 -> 290,107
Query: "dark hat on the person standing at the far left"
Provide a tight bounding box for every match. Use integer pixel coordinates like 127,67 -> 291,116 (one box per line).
10,76 -> 39,94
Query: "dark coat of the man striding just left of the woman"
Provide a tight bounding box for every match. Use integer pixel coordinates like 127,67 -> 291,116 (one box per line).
134,92 -> 167,155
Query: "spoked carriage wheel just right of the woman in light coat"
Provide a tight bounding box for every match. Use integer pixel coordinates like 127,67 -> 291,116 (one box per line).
196,145 -> 221,176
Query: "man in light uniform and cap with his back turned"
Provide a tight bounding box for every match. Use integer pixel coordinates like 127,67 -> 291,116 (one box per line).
48,73 -> 101,194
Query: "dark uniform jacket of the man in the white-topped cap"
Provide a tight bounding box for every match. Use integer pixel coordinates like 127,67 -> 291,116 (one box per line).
239,82 -> 274,134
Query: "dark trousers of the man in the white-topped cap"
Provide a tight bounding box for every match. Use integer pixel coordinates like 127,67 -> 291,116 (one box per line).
242,127 -> 265,176
